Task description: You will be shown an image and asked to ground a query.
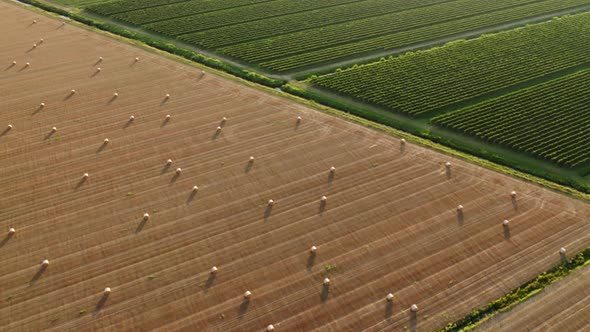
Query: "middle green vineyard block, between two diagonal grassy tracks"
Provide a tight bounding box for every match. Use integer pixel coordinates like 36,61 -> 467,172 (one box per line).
311,13 -> 590,116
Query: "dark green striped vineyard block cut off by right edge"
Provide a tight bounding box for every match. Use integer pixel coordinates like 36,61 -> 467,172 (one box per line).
433,70 -> 590,167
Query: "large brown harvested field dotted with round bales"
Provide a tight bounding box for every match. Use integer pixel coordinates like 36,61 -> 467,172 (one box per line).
0,2 -> 590,332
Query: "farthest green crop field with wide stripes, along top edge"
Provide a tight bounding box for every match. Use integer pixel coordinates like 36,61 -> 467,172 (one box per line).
87,0 -> 590,73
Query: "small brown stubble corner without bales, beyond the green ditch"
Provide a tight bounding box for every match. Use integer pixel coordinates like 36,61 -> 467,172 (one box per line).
481,266 -> 590,332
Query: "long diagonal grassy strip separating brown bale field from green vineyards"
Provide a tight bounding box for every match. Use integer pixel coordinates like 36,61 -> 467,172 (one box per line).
10,0 -> 590,202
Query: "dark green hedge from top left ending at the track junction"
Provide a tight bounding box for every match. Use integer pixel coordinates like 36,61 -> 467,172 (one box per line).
19,0 -> 286,88
